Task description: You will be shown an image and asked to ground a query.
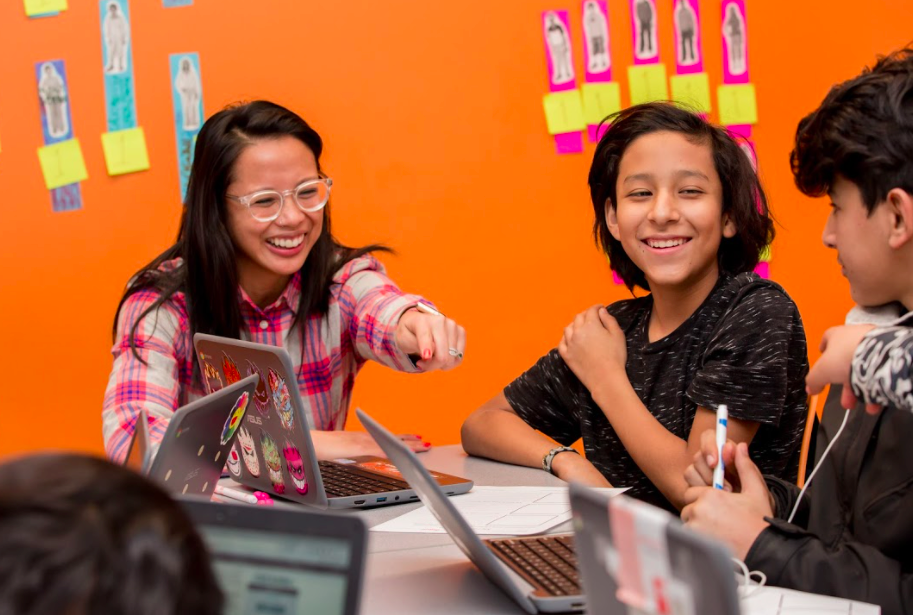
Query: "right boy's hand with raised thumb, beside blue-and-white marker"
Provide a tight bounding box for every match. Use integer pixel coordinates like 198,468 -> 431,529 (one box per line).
682,442 -> 773,560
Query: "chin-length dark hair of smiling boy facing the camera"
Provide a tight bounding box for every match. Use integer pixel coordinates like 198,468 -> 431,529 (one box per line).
589,102 -> 774,290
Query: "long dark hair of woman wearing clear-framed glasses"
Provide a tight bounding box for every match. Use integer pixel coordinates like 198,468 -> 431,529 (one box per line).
113,100 -> 389,358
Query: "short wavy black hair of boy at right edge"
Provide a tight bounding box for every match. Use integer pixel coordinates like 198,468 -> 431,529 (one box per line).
790,47 -> 913,213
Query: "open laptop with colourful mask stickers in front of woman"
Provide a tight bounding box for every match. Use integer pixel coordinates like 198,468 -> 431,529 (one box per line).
193,333 -> 472,508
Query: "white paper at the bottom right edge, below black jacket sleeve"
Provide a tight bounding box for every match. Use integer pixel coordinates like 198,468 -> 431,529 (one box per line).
739,585 -> 881,615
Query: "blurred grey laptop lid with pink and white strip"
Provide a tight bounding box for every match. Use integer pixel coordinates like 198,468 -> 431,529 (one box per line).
570,484 -> 740,615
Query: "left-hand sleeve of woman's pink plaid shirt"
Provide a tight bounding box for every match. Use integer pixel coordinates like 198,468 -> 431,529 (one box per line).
102,290 -> 188,462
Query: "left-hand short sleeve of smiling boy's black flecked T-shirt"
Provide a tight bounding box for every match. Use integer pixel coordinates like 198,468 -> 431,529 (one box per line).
504,349 -> 580,446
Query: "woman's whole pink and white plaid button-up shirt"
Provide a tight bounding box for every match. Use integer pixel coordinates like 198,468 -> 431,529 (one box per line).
102,255 -> 421,461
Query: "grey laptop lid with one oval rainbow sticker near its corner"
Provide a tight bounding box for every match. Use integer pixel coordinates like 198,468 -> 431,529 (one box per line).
124,375 -> 259,497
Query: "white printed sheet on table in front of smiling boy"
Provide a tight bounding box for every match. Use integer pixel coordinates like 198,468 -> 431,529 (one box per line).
371,485 -> 626,536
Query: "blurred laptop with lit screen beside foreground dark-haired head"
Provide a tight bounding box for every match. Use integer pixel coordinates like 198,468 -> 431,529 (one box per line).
181,498 -> 367,615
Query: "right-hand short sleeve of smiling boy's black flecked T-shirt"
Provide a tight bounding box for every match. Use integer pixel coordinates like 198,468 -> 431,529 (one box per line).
687,286 -> 808,426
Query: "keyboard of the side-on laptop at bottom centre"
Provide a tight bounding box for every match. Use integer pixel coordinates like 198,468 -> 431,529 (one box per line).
485,535 -> 582,596
